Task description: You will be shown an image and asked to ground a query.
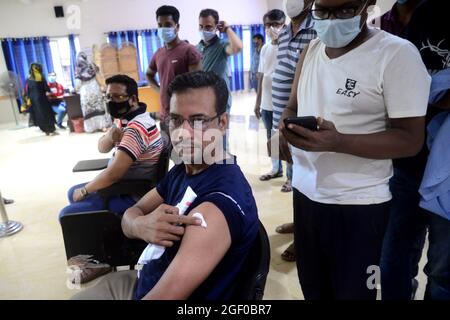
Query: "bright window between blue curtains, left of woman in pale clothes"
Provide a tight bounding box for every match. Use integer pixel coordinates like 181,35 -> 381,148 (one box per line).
50,37 -> 80,89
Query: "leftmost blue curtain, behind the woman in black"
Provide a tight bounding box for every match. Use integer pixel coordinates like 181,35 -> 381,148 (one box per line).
2,37 -> 53,105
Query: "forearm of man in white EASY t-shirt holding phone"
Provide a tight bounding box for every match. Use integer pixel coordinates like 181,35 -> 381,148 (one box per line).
332,129 -> 423,160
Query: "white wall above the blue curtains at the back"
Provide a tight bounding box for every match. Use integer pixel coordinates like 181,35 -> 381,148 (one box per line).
0,0 -> 267,48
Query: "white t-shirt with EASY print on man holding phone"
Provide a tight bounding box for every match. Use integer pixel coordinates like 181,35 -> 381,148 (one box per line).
291,31 -> 431,205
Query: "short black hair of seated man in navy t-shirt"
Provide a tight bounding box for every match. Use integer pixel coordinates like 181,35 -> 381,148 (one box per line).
168,71 -> 228,115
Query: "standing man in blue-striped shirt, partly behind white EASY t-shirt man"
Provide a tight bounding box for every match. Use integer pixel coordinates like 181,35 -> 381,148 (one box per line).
272,0 -> 317,261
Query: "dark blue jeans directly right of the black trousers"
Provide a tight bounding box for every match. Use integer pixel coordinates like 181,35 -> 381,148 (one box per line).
380,170 -> 429,300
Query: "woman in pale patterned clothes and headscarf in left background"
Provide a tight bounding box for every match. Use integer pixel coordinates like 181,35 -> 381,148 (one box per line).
75,52 -> 112,133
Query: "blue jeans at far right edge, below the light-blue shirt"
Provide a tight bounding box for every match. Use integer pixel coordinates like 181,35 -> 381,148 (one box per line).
424,213 -> 450,300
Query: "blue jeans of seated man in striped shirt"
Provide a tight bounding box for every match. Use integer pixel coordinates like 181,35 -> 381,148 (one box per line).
59,183 -> 136,219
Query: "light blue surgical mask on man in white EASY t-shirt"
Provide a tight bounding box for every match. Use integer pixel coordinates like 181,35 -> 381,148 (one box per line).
314,15 -> 362,48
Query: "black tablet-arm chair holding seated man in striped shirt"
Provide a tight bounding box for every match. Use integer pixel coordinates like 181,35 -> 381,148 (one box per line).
60,142 -> 170,268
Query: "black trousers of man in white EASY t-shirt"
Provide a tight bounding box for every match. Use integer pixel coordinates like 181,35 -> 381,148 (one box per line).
294,189 -> 390,300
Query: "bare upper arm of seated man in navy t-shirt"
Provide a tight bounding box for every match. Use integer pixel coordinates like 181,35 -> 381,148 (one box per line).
144,202 -> 231,299
